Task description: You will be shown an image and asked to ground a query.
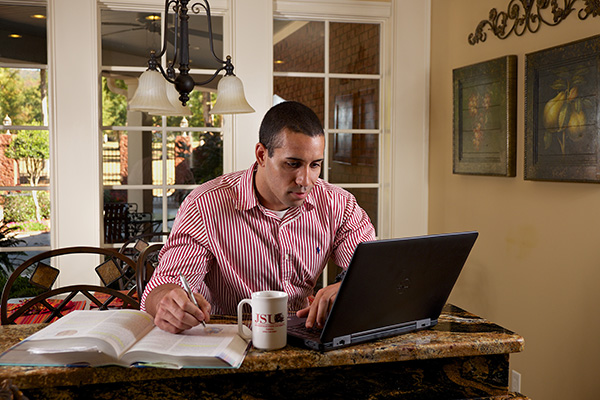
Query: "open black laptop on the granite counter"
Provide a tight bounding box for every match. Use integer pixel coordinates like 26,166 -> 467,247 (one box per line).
288,232 -> 478,351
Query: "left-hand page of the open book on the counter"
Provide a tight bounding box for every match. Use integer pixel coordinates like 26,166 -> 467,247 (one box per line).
27,309 -> 154,357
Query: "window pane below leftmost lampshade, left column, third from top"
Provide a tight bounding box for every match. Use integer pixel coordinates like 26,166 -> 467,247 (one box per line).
102,131 -> 162,185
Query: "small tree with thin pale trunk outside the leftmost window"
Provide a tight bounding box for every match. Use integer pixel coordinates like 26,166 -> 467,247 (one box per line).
5,131 -> 50,222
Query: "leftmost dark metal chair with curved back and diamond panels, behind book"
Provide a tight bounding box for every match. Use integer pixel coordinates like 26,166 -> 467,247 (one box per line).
0,246 -> 139,325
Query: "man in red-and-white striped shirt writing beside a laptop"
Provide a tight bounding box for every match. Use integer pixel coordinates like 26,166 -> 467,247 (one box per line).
142,102 -> 375,333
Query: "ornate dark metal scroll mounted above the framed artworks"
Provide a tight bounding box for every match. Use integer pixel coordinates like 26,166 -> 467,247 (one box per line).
469,0 -> 600,45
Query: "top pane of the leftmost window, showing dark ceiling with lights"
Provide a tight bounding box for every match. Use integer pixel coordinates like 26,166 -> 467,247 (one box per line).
0,5 -> 48,64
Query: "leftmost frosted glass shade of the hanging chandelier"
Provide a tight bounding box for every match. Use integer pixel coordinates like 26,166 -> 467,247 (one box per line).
129,70 -> 173,112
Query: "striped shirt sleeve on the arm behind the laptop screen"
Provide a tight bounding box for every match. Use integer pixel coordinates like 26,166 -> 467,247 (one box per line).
333,191 -> 375,269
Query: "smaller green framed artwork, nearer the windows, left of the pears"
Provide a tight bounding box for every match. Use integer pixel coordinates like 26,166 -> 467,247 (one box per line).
452,55 -> 517,176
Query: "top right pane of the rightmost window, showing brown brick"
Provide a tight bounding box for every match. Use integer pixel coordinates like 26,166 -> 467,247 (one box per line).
329,22 -> 379,74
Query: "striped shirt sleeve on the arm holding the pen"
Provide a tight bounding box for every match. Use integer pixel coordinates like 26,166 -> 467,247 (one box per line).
140,197 -> 214,311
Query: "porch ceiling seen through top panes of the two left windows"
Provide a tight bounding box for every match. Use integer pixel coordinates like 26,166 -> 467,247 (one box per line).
0,5 -> 224,69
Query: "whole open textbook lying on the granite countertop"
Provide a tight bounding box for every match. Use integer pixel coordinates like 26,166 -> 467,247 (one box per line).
0,310 -> 248,368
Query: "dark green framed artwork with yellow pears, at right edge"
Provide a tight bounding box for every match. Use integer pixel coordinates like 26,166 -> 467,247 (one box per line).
525,36 -> 600,182
